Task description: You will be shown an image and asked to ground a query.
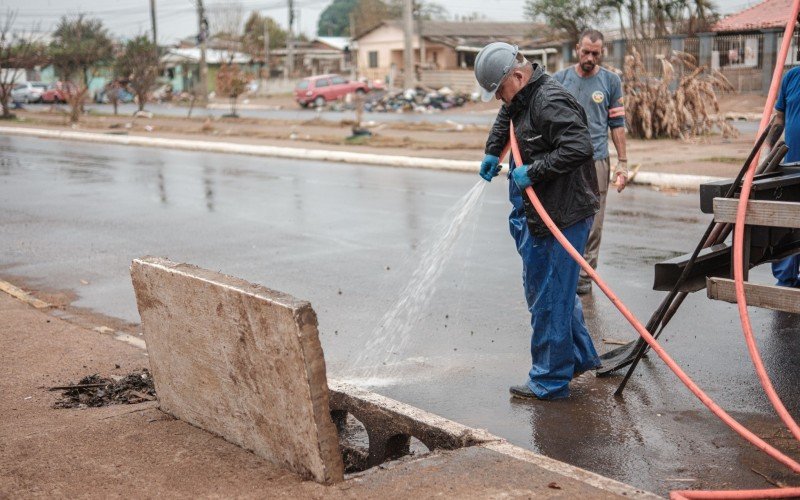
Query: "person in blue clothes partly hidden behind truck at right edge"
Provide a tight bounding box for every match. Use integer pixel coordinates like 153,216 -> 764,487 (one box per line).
768,66 -> 800,288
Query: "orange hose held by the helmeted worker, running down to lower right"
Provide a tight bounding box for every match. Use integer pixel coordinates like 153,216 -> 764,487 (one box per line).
510,123 -> 800,473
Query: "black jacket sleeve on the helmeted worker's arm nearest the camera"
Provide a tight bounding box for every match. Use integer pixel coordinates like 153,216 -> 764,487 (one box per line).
524,92 -> 593,184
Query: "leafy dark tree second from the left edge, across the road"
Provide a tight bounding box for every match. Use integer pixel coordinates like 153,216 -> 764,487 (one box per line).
50,14 -> 113,123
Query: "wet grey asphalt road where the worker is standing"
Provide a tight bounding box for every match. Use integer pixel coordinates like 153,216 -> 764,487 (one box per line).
0,137 -> 800,494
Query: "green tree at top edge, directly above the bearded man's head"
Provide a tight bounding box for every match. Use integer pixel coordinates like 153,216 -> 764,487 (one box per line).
525,0 -> 608,44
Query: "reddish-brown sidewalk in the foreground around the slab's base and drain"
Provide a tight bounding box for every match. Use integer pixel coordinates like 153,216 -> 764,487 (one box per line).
0,292 -> 656,498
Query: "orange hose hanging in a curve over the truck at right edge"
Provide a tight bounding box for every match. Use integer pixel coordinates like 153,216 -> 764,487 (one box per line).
733,0 -> 800,441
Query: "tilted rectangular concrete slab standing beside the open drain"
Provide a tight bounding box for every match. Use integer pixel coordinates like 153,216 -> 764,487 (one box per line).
131,257 -> 343,483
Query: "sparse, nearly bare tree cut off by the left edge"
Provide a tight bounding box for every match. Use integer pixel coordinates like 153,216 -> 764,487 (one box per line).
0,9 -> 47,119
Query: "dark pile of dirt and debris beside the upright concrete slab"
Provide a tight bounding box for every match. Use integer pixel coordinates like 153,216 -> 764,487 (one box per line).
49,369 -> 156,408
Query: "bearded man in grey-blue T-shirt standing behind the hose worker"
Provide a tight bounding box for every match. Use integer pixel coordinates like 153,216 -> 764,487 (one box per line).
553,29 -> 628,295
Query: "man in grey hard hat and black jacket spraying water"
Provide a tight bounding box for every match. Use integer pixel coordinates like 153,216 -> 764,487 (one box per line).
475,42 -> 600,399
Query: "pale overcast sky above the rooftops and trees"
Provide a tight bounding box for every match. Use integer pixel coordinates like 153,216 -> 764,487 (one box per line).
0,0 -> 757,44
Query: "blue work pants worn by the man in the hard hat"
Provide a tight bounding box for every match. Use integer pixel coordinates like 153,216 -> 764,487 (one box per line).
508,175 -> 600,399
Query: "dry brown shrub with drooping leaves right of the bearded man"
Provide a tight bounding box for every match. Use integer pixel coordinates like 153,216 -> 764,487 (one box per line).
623,48 -> 739,139
